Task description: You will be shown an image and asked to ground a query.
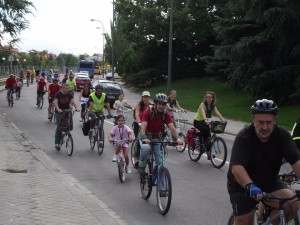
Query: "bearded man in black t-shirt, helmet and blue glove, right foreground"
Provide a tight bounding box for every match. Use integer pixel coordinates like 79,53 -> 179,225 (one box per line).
227,99 -> 300,225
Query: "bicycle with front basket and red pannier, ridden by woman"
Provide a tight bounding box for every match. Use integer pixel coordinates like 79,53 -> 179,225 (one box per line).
186,121 -> 227,169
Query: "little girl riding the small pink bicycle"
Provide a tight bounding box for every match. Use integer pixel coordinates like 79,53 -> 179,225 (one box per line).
108,115 -> 135,173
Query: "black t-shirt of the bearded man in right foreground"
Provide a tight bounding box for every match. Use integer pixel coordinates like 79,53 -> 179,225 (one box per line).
227,124 -> 300,192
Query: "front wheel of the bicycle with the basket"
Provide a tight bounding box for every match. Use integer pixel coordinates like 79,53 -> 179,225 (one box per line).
210,137 -> 227,169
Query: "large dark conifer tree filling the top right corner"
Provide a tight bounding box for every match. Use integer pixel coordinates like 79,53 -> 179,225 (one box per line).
206,0 -> 300,103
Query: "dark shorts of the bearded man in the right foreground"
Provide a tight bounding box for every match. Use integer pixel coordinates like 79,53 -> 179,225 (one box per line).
229,181 -> 287,216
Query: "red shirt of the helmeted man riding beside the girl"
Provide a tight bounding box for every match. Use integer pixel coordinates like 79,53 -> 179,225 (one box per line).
142,108 -> 173,138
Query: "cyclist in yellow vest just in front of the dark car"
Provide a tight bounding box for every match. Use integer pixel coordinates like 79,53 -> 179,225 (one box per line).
89,85 -> 112,145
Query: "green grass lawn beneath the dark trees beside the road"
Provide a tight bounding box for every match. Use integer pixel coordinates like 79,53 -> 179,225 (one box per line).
140,77 -> 300,130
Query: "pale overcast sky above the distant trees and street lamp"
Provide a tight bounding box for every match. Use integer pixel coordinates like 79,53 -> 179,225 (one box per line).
5,0 -> 113,55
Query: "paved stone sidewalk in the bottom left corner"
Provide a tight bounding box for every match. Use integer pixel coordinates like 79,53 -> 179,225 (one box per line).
0,109 -> 127,225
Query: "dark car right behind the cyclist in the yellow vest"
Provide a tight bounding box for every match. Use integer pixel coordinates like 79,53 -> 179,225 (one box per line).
93,80 -> 123,107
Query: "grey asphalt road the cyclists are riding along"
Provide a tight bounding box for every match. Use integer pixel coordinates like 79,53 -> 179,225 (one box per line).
0,81 -> 234,225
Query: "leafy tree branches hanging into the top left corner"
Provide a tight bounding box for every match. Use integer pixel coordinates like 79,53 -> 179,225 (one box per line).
0,0 -> 35,46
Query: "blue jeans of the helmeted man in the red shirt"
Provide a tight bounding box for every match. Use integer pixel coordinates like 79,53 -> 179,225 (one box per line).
139,139 -> 162,168
